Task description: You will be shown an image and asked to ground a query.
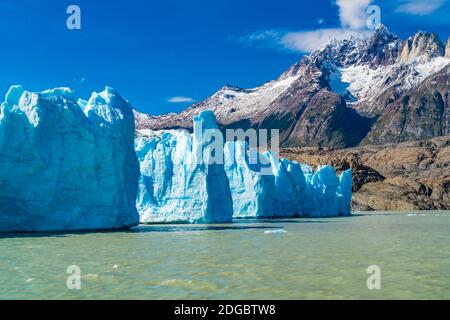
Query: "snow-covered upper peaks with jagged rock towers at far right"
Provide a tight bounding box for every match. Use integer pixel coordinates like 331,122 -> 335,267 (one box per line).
317,26 -> 450,115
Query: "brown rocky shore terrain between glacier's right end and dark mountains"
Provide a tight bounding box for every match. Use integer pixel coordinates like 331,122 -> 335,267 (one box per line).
281,136 -> 450,211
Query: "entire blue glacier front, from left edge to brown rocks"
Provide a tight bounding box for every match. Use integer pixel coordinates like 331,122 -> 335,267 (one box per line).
0,86 -> 352,232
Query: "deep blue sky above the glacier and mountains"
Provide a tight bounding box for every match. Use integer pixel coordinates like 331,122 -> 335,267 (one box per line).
0,0 -> 450,114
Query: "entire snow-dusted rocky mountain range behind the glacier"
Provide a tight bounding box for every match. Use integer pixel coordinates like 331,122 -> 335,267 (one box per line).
136,26 -> 450,148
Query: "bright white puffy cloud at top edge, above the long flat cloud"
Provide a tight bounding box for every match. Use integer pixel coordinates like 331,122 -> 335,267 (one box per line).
336,0 -> 372,29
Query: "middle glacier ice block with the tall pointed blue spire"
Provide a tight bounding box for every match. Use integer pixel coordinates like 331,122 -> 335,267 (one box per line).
136,111 -> 233,223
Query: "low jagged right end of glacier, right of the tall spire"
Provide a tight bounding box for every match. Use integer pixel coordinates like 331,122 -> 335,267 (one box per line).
225,141 -> 352,218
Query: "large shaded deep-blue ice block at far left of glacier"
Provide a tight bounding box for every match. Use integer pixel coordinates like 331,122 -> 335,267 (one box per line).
0,86 -> 139,232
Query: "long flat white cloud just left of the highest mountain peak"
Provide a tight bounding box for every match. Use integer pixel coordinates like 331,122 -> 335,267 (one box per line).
283,28 -> 365,52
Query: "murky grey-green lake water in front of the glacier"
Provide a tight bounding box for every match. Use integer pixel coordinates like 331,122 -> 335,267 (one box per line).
0,211 -> 450,299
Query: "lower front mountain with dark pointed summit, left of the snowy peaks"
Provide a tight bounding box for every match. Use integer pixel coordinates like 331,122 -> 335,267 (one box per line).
136,52 -> 370,147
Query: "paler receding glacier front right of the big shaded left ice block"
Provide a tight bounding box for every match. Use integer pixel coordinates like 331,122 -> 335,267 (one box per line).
136,110 -> 352,223
